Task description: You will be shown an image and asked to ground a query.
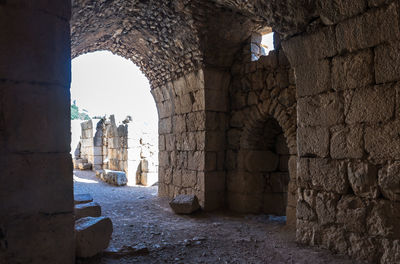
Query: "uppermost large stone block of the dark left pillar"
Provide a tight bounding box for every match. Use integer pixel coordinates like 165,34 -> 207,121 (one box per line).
0,6 -> 71,84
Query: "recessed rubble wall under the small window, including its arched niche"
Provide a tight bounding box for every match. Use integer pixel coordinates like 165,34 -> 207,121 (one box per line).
226,37 -> 297,224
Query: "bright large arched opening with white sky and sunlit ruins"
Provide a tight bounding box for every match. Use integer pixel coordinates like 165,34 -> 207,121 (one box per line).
71,51 -> 158,185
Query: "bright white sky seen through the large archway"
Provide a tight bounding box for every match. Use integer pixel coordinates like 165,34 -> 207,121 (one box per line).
71,51 -> 158,132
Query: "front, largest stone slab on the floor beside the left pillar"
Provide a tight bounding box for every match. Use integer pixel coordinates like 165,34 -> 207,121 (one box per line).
75,216 -> 113,258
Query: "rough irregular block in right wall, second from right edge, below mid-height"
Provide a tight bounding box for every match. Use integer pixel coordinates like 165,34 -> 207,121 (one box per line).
347,161 -> 379,198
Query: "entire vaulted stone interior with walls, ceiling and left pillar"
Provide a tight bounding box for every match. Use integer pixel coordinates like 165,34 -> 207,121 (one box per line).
0,0 -> 400,263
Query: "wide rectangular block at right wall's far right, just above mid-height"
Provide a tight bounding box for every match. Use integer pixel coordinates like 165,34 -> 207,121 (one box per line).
344,85 -> 396,124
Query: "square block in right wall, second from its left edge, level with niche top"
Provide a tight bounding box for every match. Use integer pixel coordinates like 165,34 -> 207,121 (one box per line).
330,125 -> 364,159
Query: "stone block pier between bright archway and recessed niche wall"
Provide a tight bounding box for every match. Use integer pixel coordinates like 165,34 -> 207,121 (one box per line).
152,68 -> 230,210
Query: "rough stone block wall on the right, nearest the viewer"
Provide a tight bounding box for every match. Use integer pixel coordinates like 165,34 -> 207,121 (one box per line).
283,0 -> 400,263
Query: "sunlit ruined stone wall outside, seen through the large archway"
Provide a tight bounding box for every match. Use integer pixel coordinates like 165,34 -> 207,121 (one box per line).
74,115 -> 158,185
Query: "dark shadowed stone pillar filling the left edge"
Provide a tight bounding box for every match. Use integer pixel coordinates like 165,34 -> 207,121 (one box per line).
0,0 -> 75,264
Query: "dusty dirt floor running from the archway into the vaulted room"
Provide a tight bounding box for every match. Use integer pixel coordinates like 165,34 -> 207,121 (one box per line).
74,171 -> 356,264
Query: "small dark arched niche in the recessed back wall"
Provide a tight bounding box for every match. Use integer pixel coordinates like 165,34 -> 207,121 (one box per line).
228,117 -> 290,220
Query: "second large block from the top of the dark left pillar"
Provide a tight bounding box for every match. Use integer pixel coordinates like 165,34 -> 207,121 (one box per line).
0,83 -> 71,152
